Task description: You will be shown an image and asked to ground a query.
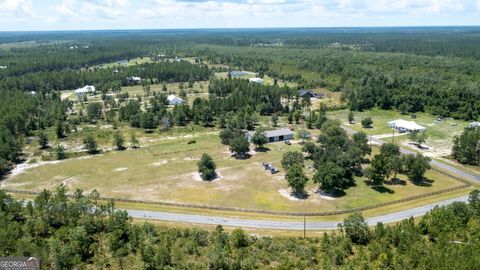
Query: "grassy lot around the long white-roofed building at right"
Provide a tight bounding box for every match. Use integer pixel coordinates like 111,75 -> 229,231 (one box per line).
328,109 -> 468,156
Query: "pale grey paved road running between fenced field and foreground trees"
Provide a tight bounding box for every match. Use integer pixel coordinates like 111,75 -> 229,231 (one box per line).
127,196 -> 468,230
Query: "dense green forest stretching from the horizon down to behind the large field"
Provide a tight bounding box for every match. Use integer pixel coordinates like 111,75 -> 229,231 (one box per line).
0,27 -> 480,176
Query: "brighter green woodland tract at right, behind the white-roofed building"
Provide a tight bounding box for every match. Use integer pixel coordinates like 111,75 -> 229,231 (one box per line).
194,47 -> 480,120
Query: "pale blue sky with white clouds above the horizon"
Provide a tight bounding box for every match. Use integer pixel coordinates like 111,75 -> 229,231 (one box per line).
0,0 -> 480,31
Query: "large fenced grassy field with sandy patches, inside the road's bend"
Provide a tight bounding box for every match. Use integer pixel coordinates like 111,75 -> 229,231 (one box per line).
3,132 -> 461,211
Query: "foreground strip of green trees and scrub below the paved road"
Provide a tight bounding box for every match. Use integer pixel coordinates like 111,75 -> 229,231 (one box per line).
0,186 -> 480,269
